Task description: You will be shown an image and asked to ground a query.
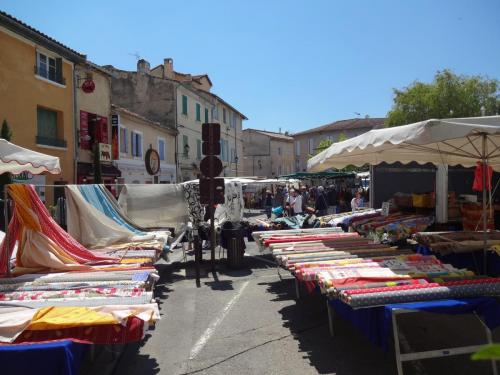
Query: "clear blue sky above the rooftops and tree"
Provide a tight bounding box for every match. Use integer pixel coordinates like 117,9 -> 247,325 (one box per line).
0,0 -> 500,132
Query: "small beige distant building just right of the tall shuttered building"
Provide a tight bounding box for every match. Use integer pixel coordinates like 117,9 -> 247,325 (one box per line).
243,129 -> 294,178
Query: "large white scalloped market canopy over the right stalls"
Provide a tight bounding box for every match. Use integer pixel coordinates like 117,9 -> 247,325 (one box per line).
307,116 -> 500,172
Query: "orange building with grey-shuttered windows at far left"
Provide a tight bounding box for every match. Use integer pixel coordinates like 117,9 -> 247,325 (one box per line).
0,11 -> 86,204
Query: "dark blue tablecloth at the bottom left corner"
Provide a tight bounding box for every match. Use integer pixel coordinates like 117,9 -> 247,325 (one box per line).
0,340 -> 89,375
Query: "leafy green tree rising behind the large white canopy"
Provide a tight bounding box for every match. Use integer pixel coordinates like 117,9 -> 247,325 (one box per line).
386,69 -> 500,126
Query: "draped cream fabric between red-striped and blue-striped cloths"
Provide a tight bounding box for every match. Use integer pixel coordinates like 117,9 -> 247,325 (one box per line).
66,185 -> 150,248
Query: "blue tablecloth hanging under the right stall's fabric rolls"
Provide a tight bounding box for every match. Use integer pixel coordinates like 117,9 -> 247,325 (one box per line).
329,297 -> 500,349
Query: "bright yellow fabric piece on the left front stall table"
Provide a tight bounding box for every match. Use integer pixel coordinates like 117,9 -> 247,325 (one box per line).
27,306 -> 119,331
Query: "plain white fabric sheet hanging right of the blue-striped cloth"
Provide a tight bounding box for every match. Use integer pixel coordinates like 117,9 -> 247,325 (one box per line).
118,184 -> 188,232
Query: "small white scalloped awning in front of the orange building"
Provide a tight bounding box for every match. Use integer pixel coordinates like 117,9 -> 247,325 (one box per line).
0,139 -> 61,174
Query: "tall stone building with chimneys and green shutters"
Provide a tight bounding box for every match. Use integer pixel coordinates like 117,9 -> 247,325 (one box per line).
105,59 -> 247,181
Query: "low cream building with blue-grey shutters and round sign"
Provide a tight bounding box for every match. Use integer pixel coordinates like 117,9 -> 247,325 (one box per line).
111,105 -> 177,184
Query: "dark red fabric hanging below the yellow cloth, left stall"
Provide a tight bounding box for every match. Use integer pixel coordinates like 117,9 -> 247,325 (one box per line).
14,316 -> 144,344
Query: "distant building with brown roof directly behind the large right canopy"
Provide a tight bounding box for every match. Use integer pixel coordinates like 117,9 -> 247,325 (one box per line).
293,118 -> 385,172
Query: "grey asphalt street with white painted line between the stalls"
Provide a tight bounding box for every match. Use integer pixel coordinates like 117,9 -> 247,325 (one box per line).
87,210 -> 498,375
